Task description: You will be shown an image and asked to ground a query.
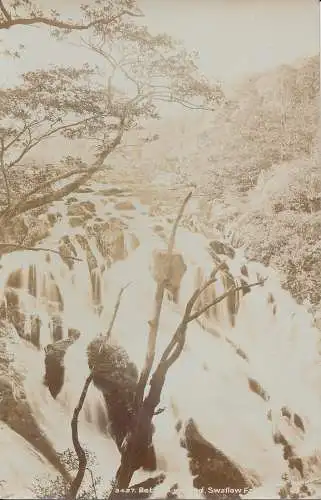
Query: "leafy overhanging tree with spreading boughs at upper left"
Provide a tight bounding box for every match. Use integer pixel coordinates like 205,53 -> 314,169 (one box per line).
0,0 -> 224,225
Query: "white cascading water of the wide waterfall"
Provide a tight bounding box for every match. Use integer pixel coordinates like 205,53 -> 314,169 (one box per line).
0,186 -> 321,498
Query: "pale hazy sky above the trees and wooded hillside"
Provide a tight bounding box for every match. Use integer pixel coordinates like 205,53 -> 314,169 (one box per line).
0,0 -> 320,89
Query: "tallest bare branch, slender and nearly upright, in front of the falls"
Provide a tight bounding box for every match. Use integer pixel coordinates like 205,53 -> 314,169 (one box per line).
135,192 -> 192,408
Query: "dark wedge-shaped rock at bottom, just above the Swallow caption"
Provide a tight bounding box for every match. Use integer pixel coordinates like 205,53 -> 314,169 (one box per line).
185,420 -> 250,500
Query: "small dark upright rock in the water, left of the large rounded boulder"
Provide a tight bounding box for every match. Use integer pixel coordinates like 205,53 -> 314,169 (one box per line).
44,337 -> 75,399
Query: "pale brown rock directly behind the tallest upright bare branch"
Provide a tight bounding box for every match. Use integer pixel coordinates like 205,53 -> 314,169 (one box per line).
151,250 -> 187,302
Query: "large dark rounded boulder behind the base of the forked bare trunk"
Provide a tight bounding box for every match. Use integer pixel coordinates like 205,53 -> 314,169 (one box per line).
88,337 -> 156,470
